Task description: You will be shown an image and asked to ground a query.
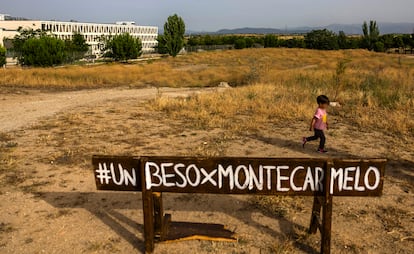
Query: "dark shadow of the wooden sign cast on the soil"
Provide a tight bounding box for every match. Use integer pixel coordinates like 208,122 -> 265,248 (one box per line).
38,192 -> 319,253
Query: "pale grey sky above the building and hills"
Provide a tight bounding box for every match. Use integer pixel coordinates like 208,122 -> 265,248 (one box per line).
0,0 -> 414,32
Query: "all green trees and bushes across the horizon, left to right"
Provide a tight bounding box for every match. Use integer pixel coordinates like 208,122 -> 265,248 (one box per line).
0,17 -> 414,66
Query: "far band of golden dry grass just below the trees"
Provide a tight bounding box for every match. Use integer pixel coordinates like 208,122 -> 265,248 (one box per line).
0,49 -> 414,89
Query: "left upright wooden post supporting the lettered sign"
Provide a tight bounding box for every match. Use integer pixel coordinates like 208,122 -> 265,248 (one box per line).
141,159 -> 155,253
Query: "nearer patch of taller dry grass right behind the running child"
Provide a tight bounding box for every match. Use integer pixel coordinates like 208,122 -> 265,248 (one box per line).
151,78 -> 414,140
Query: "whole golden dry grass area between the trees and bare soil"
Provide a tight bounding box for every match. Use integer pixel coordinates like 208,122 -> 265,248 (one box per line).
0,49 -> 414,138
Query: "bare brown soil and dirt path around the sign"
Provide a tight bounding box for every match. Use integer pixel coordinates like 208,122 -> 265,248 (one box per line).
0,88 -> 414,253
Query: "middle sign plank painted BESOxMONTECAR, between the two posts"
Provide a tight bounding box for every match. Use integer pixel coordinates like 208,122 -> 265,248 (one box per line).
145,157 -> 324,195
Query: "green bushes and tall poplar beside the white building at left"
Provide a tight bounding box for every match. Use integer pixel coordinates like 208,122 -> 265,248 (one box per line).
0,14 -> 185,67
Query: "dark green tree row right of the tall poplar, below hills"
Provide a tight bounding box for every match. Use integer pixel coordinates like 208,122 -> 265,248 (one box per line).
187,21 -> 414,52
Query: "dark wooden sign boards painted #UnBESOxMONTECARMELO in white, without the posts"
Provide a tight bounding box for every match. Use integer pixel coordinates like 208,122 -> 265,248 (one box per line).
93,157 -> 385,196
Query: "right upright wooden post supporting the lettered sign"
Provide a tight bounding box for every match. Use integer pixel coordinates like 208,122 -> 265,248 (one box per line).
321,160 -> 333,254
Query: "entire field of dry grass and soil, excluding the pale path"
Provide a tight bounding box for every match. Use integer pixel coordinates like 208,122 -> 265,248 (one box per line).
0,49 -> 414,253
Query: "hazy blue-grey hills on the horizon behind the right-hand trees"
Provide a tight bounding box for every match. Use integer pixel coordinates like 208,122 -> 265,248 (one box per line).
207,23 -> 414,34
